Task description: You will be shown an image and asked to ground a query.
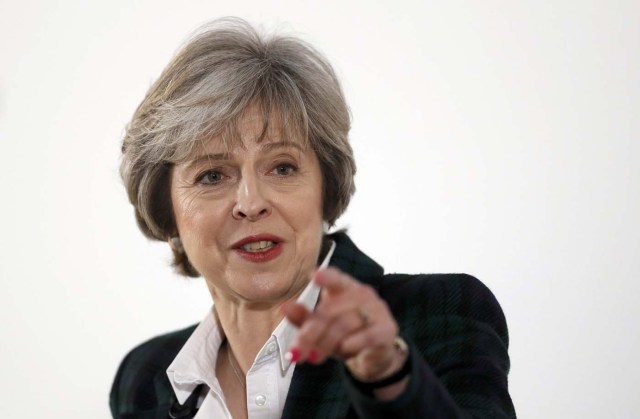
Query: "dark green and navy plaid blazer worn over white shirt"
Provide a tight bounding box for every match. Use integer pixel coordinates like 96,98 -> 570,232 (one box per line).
110,233 -> 515,419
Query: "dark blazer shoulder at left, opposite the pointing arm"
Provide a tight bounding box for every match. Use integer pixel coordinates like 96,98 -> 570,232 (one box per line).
109,325 -> 197,417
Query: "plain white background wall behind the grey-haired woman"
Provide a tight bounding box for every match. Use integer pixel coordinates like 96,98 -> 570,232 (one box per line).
0,0 -> 640,418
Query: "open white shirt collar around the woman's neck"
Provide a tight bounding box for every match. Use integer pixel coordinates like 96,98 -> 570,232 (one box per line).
167,241 -> 336,404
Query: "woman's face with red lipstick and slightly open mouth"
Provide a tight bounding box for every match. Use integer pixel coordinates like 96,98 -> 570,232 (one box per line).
171,109 -> 323,302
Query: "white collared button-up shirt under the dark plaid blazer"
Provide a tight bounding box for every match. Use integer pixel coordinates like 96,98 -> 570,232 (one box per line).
167,243 -> 335,419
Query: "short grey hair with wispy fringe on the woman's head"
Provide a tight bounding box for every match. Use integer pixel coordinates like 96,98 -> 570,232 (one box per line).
120,18 -> 356,276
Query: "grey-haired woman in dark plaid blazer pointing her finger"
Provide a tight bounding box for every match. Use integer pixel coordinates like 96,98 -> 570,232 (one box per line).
111,19 -> 515,418
